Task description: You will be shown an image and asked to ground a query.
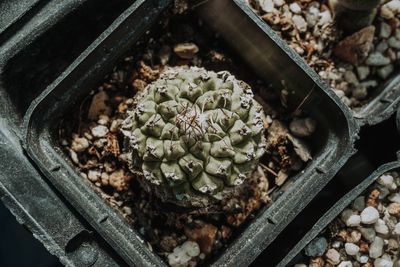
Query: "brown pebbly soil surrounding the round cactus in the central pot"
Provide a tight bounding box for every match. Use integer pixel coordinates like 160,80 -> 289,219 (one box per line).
59,7 -> 316,266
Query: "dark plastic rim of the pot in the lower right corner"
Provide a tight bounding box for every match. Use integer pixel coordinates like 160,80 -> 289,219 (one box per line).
277,161 -> 400,267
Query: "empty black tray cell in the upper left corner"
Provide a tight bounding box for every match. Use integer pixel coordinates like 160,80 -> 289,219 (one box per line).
1,0 -> 132,120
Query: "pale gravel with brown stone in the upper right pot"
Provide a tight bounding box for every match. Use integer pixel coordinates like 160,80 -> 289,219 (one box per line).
248,0 -> 400,108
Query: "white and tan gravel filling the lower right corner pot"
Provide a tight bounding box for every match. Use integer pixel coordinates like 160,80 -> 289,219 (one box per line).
297,172 -> 400,267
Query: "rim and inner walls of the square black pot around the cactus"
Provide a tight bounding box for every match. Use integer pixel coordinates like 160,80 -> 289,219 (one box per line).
22,0 -> 358,266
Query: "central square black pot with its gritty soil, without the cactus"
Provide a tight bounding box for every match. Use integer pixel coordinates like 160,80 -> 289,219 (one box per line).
23,1 -> 357,266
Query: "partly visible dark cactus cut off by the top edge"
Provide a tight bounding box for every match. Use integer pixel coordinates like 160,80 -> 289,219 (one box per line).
330,0 -> 380,33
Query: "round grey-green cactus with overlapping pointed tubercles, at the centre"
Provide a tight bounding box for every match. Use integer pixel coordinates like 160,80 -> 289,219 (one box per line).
121,67 -> 266,207
